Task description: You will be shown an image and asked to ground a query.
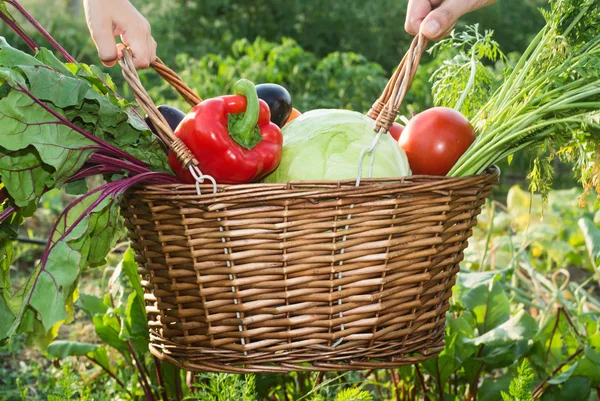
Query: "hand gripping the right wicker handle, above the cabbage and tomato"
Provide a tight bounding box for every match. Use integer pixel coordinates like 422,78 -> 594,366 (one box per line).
404,0 -> 496,40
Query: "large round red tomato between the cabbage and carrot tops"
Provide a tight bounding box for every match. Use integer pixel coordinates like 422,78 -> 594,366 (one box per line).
398,107 -> 475,175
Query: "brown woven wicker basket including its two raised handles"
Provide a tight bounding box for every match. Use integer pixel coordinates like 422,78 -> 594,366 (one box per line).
117,34 -> 499,373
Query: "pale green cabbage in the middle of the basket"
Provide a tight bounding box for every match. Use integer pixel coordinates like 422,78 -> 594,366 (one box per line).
265,110 -> 411,182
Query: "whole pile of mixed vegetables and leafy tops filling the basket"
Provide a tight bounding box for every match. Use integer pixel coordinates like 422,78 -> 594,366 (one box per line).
0,0 -> 600,345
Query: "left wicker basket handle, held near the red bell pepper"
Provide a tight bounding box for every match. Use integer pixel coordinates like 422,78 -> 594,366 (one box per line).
119,48 -> 202,167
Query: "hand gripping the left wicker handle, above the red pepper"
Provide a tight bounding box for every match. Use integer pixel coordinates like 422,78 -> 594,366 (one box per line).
83,0 -> 156,68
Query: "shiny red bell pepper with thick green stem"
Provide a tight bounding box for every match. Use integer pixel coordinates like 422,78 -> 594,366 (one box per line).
169,79 -> 283,184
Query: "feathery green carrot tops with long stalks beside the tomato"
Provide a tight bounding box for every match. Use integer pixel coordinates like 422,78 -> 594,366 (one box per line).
436,0 -> 600,198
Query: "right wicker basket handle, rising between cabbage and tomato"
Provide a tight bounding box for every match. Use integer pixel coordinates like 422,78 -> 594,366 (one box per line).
367,33 -> 428,131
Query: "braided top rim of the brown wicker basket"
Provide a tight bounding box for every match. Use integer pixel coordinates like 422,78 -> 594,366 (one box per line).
126,165 -> 501,199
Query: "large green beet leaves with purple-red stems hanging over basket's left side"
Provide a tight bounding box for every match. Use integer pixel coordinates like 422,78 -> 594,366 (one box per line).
0,32 -> 175,347
